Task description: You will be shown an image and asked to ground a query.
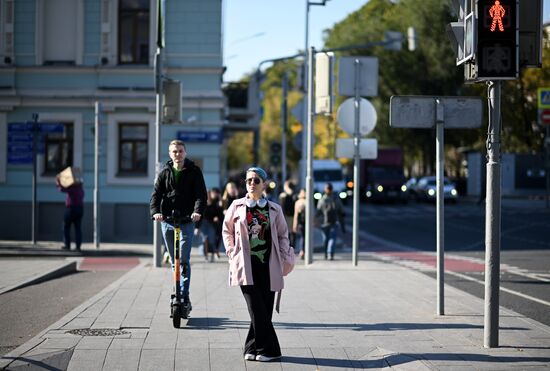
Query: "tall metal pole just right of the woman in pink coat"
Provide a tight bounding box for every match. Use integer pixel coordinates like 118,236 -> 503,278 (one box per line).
305,47 -> 315,265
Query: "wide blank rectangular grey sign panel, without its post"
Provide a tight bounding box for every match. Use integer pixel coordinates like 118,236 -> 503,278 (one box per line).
390,95 -> 483,129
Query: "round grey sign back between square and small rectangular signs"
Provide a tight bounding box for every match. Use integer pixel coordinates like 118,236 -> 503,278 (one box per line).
336,98 -> 377,136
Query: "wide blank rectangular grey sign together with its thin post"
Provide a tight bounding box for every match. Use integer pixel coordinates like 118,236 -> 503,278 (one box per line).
390,95 -> 483,315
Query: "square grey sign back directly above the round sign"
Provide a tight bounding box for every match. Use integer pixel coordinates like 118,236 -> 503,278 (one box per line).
338,57 -> 378,97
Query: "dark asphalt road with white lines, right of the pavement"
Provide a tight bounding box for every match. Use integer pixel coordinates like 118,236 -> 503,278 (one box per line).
354,201 -> 550,325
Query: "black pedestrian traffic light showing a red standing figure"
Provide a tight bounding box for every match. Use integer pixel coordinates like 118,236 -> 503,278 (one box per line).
475,0 -> 519,80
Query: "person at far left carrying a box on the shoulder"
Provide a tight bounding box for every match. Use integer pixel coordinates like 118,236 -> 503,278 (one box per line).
55,175 -> 84,251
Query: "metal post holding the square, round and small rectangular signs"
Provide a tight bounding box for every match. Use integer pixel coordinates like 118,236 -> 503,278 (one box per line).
351,59 -> 361,267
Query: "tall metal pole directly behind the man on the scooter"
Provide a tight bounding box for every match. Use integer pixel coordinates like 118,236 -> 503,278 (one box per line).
153,48 -> 162,268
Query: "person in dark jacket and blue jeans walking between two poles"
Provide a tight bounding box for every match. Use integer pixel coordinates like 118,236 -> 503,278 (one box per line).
317,183 -> 346,260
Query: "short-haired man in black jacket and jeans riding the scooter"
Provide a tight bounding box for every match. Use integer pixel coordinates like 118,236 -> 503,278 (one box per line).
150,140 -> 206,311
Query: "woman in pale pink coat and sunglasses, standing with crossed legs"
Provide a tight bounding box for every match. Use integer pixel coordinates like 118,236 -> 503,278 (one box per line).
222,167 -> 294,362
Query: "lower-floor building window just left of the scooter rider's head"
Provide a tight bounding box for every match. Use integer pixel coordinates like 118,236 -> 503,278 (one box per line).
118,123 -> 149,175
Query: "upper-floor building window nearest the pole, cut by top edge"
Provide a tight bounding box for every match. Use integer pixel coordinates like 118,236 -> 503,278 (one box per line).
118,0 -> 150,64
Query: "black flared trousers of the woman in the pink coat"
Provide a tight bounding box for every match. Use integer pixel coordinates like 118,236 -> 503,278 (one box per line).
241,272 -> 281,357
